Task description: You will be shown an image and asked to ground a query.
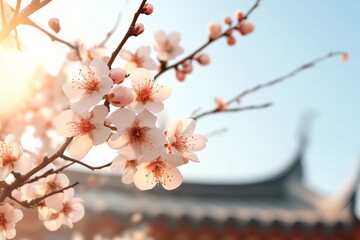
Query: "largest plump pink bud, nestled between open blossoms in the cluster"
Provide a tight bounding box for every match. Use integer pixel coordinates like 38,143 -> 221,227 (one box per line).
108,84 -> 134,107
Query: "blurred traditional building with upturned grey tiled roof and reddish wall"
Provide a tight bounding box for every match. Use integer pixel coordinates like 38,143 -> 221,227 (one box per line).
14,139 -> 360,240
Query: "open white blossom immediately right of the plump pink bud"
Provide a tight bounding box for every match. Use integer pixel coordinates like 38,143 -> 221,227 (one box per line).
129,68 -> 171,113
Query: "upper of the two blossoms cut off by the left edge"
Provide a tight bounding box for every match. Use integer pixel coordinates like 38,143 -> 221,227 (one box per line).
0,134 -> 32,181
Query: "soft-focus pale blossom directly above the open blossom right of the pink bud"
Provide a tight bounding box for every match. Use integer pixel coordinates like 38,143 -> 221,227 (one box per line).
120,46 -> 156,73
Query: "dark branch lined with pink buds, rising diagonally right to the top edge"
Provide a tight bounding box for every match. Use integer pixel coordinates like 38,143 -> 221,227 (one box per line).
154,0 -> 260,80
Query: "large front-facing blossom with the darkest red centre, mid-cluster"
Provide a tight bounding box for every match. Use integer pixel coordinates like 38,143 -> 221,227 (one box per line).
108,108 -> 166,160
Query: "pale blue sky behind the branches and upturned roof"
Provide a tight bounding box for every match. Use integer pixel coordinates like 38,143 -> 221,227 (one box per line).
6,0 -> 360,204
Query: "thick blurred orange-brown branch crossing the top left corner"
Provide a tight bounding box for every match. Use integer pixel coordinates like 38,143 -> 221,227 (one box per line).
0,0 -> 52,43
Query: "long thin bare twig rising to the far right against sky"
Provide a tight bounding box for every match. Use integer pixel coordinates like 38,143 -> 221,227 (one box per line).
227,52 -> 345,105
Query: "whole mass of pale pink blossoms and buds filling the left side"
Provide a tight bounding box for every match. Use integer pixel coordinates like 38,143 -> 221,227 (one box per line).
0,1 -> 254,238
